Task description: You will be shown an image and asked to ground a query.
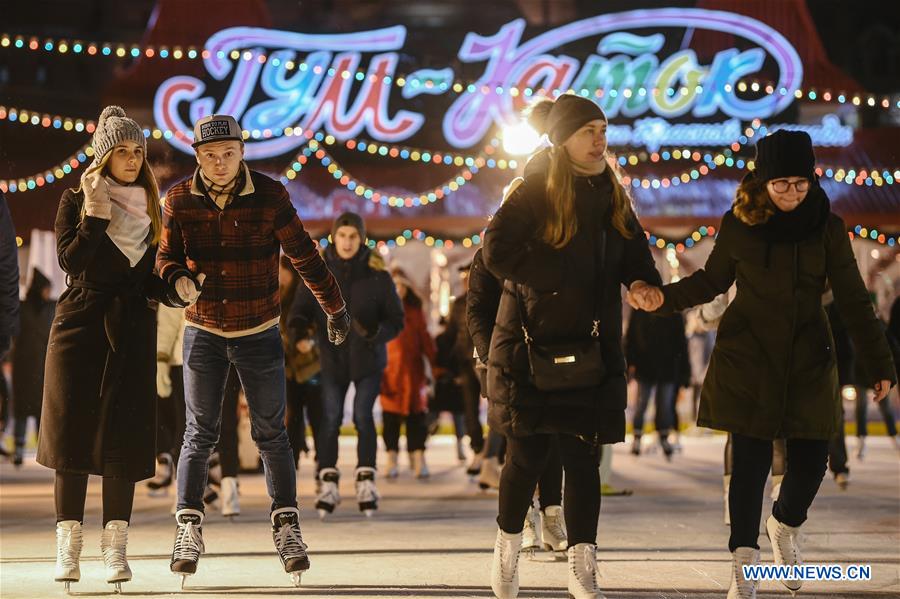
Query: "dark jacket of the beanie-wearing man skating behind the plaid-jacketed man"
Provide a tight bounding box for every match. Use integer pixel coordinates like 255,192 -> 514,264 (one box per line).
288,246 -> 403,381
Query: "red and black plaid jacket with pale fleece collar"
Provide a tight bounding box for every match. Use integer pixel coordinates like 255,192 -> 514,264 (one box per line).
156,168 -> 344,332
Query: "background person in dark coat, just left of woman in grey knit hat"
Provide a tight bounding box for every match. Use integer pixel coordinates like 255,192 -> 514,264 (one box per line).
12,268 -> 56,466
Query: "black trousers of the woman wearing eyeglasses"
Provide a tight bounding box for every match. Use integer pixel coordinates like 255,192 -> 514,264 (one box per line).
728,433 -> 828,552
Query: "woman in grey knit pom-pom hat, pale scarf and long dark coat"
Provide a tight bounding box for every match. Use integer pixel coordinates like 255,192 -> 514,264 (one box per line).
37,106 -> 183,587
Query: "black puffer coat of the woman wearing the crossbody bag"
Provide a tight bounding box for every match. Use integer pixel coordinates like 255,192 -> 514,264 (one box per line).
484,153 -> 660,443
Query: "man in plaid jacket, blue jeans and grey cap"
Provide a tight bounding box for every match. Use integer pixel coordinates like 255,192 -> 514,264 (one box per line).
157,115 -> 350,582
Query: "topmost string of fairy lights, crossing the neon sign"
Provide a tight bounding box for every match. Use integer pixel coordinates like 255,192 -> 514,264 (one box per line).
0,33 -> 900,109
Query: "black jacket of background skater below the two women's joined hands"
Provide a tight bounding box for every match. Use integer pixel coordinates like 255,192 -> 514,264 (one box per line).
625,310 -> 691,387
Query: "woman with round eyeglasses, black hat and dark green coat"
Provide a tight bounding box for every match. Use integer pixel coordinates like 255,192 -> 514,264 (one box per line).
632,130 -> 897,599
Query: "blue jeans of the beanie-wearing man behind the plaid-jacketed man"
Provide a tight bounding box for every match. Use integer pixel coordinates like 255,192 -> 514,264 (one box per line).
316,371 -> 381,470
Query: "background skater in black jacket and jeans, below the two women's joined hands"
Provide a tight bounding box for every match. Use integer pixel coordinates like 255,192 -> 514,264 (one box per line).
625,310 -> 691,460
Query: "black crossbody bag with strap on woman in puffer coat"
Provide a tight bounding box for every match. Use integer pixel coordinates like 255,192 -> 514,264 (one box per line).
515,230 -> 606,391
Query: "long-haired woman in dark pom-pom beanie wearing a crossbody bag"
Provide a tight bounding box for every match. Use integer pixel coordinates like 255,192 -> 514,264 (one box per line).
483,94 -> 660,599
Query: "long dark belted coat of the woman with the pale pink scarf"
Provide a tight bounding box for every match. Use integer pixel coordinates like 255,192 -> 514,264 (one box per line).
37,190 -> 177,482
